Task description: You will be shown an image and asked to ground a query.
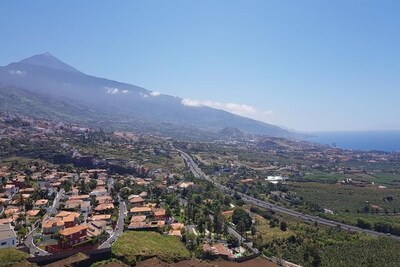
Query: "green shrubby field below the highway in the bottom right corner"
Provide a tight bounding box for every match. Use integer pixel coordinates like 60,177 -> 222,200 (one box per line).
253,208 -> 400,267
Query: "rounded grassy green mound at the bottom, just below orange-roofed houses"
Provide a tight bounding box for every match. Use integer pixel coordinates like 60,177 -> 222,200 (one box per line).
111,231 -> 190,265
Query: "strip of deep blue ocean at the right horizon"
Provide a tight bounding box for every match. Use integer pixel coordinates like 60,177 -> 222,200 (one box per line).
307,131 -> 400,152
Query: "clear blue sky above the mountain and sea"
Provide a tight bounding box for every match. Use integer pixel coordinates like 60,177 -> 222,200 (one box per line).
0,0 -> 400,131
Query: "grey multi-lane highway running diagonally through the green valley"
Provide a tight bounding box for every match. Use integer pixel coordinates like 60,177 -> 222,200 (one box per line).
175,148 -> 400,243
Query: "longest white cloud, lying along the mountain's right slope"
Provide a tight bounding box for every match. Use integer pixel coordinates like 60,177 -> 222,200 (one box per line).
181,98 -> 273,120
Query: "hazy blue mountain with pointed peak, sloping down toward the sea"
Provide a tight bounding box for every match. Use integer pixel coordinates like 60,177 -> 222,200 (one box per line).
0,53 -> 300,137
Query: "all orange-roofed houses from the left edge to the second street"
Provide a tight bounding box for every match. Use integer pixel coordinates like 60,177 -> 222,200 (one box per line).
0,163 -> 119,252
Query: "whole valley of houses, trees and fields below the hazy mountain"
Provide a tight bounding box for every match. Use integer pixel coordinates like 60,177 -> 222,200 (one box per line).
0,113 -> 400,266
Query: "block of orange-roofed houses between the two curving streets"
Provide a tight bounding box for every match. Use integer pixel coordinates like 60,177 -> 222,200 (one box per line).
42,169 -> 115,253
